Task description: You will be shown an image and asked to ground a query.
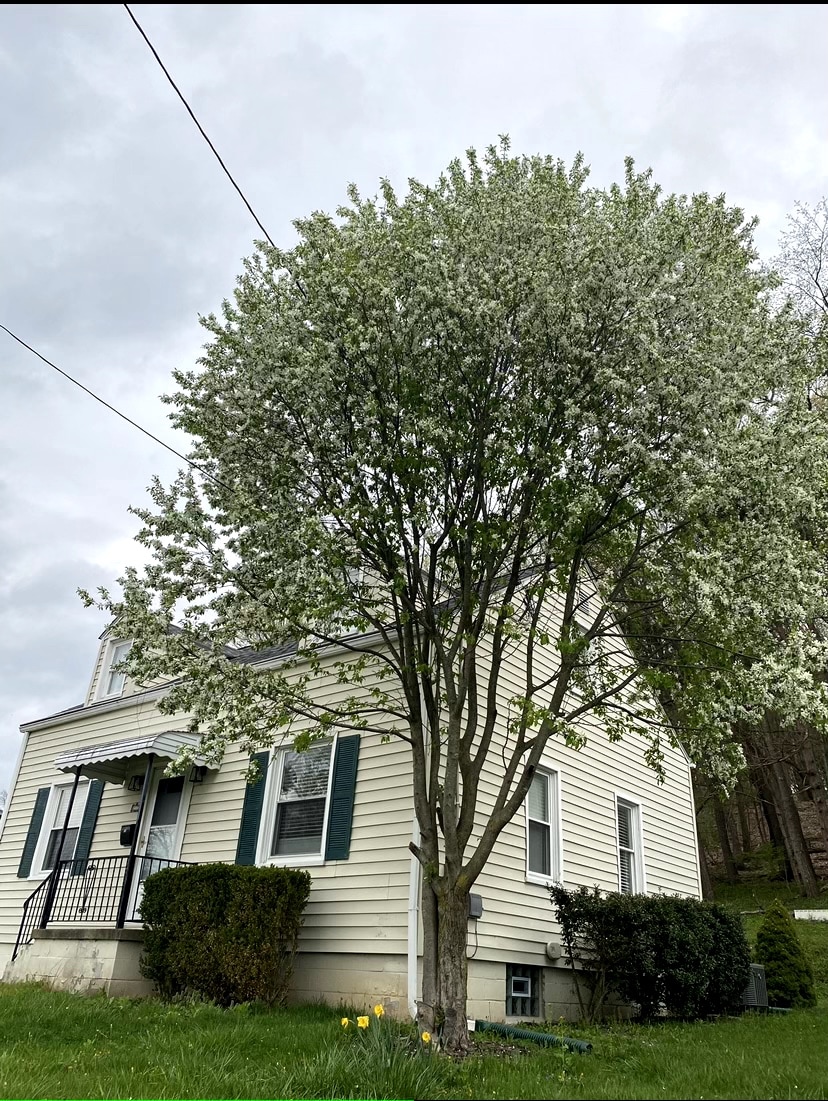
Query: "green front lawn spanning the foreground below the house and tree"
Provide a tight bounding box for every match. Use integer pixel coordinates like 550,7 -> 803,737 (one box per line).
0,982 -> 828,1101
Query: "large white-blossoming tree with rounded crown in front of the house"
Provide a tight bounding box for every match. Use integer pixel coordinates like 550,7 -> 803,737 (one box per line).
84,143 -> 825,1049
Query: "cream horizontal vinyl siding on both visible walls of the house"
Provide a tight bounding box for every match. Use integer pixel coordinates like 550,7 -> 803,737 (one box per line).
0,612 -> 698,982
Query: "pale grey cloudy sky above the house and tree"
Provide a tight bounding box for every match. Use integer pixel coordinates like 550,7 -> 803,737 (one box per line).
0,4 -> 828,788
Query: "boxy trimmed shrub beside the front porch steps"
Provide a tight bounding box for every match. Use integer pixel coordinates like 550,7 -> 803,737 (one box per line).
141,864 -> 311,1005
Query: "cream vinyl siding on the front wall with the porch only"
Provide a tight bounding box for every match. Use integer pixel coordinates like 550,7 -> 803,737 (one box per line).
0,657 -> 413,953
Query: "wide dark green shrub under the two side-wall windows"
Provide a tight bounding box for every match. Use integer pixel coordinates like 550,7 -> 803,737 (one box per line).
549,886 -> 750,1021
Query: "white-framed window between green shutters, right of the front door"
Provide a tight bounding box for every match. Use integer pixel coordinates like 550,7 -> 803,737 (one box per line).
266,742 -> 333,861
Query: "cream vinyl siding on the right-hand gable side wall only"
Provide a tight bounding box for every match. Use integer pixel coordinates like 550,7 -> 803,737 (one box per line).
471,616 -> 699,963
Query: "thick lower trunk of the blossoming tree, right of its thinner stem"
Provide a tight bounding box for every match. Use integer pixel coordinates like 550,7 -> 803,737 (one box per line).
437,884 -> 469,1053
